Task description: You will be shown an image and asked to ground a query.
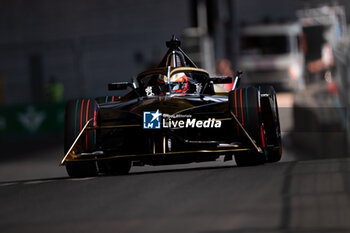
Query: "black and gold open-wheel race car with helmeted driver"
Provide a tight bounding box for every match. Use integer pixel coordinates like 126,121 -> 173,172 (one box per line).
61,36 -> 282,177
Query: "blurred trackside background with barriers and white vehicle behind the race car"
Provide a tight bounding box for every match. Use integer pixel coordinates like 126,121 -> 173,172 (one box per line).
0,0 -> 350,179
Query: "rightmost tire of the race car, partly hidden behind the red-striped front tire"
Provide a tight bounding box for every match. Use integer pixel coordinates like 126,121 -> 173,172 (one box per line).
259,86 -> 282,163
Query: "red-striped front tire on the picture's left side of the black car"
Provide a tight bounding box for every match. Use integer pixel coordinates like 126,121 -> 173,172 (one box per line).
64,99 -> 98,177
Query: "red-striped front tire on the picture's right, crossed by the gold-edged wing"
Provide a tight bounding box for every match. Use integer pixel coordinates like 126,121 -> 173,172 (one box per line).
229,87 -> 266,166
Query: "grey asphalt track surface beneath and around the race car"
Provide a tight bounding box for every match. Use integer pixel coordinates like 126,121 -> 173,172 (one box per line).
0,93 -> 350,233
